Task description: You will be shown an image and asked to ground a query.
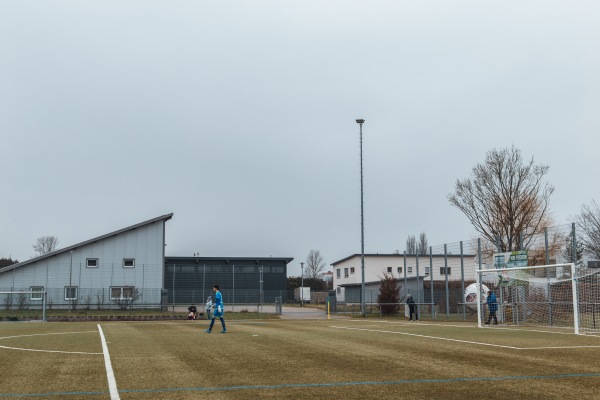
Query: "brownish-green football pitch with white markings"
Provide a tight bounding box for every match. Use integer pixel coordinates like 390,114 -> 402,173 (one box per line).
0,318 -> 600,400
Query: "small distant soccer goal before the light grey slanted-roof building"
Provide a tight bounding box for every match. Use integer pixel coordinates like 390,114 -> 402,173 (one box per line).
0,290 -> 47,322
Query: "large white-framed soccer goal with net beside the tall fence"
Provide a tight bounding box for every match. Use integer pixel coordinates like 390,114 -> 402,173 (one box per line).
477,263 -> 600,334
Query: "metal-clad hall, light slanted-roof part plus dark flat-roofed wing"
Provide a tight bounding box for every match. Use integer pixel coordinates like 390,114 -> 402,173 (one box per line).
0,213 -> 293,309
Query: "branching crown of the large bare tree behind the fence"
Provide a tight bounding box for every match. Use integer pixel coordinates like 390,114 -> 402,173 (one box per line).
448,146 -> 554,251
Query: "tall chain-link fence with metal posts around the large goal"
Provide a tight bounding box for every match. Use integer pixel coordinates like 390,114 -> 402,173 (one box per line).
336,224 -> 600,320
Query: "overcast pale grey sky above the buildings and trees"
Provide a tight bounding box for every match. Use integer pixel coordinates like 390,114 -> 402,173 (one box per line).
0,0 -> 600,275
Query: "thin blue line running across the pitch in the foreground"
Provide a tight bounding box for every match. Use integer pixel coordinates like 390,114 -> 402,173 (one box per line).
0,373 -> 600,397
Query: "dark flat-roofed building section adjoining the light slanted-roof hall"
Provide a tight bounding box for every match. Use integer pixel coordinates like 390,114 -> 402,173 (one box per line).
163,257 -> 293,309
